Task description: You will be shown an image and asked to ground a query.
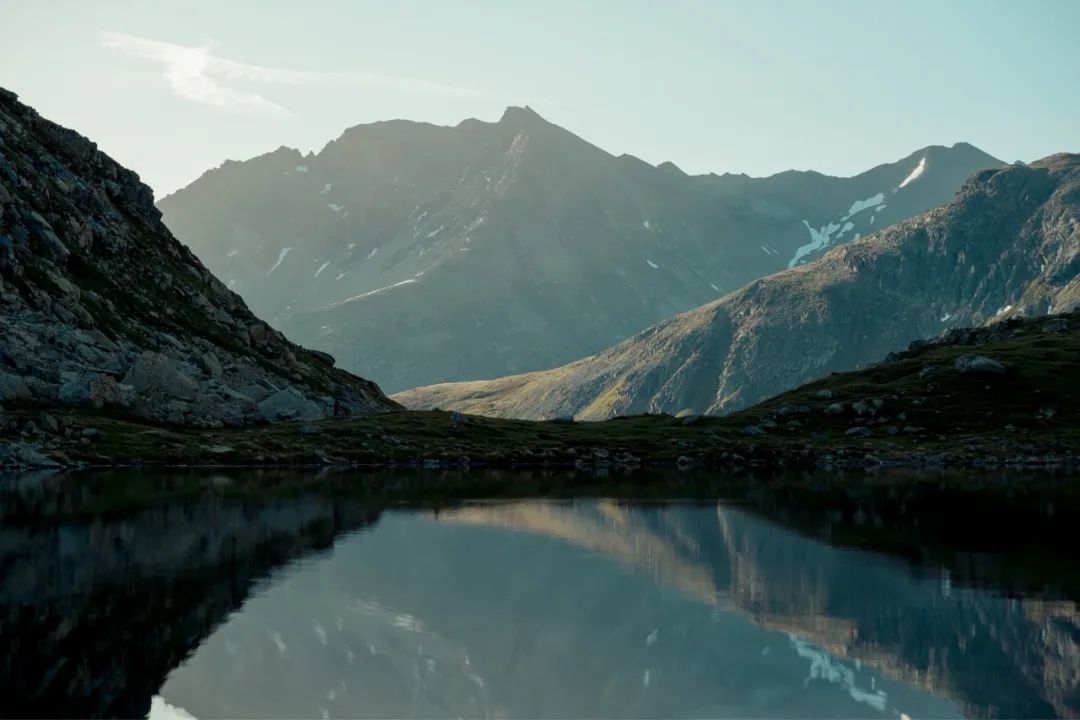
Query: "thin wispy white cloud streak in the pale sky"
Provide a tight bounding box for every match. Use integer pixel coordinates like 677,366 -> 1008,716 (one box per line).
102,32 -> 496,113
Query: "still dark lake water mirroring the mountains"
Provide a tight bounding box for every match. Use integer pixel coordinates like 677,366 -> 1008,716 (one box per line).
0,474 -> 1080,720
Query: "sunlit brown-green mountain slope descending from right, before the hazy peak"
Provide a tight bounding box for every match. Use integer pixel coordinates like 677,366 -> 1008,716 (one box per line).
397,154 -> 1080,419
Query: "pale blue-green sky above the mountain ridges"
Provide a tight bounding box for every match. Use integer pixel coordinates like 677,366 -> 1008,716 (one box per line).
0,0 -> 1080,198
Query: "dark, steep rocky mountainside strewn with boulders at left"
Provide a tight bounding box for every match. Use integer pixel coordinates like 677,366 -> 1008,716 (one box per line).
0,90 -> 396,424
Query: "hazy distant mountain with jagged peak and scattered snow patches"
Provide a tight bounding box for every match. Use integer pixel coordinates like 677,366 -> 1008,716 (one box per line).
159,108 -> 1000,390
